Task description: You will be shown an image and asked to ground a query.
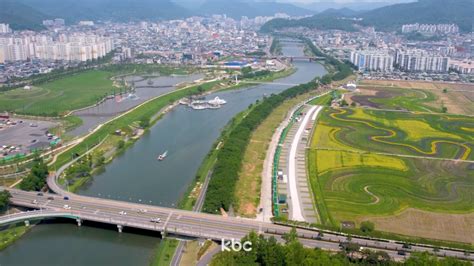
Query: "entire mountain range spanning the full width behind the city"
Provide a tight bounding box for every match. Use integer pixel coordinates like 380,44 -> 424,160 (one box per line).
0,0 -> 474,32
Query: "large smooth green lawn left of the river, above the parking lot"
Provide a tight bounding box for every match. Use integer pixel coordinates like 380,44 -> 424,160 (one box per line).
0,70 -> 119,116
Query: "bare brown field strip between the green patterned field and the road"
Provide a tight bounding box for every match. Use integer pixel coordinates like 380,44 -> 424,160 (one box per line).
357,208 -> 474,244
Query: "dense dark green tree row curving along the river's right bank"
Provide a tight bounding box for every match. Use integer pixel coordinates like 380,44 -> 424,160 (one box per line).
203,81 -> 318,213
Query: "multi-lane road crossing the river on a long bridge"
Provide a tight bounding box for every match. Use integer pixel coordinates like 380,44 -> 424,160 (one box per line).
0,189 -> 474,260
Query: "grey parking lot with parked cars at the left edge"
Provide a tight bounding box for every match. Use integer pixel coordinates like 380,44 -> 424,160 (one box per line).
0,119 -> 57,158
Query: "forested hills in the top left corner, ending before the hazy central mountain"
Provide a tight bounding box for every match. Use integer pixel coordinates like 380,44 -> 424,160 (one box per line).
0,0 -> 192,29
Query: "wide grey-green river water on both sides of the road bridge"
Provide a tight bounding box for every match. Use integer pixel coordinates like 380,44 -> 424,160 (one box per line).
0,41 -> 326,266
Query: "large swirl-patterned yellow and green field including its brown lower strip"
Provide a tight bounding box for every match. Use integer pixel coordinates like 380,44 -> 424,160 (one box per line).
308,107 -> 474,243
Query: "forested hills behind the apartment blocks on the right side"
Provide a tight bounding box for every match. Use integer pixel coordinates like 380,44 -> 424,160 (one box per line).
262,0 -> 474,32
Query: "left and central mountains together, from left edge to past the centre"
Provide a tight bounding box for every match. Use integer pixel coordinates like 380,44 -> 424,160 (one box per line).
0,0 -> 315,30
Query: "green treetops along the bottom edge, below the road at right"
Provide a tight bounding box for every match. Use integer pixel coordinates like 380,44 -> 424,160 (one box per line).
211,229 -> 470,266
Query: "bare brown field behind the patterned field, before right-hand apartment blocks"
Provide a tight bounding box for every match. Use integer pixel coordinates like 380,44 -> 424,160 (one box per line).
354,80 -> 474,115
